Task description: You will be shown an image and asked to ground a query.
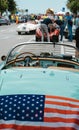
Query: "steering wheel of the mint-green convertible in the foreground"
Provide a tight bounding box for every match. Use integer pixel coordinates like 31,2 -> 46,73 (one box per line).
14,52 -> 36,66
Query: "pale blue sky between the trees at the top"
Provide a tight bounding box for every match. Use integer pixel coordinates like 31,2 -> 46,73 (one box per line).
15,0 -> 67,13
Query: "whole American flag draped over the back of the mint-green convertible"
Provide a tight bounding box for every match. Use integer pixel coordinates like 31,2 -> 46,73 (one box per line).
0,94 -> 79,130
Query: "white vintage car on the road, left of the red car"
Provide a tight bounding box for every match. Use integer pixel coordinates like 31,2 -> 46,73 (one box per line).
17,21 -> 37,35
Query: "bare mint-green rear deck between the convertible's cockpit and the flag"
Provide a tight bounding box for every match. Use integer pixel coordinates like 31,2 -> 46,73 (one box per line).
0,68 -> 79,99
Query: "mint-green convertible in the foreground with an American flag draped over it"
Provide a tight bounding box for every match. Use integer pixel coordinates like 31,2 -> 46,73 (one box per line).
0,42 -> 79,130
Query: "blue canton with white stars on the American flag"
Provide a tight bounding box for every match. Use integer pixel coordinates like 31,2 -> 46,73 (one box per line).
0,94 -> 45,121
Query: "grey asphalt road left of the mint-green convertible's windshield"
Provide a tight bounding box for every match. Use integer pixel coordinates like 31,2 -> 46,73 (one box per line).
0,23 -> 34,61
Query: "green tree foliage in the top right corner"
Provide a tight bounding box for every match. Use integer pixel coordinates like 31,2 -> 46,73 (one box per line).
67,0 -> 79,14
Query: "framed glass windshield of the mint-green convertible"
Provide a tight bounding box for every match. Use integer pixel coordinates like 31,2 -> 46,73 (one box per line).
6,42 -> 78,63
